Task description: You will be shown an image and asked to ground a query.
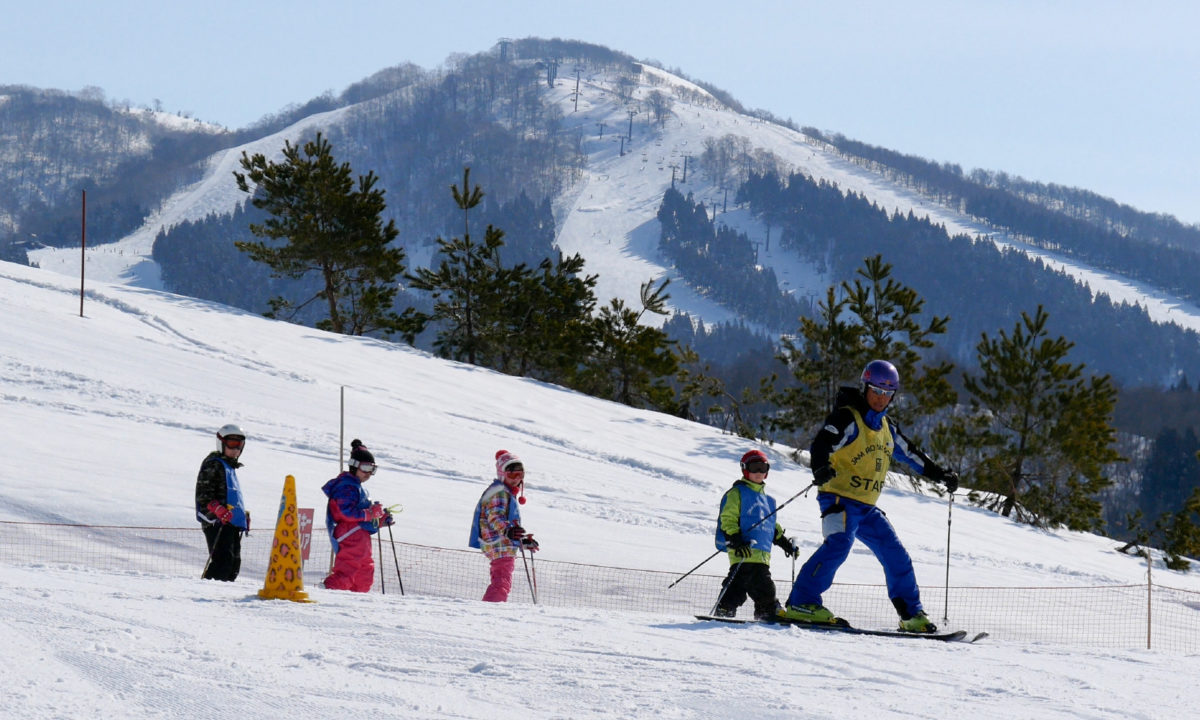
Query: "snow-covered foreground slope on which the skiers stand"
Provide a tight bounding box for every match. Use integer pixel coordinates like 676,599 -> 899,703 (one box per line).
0,256 -> 1200,720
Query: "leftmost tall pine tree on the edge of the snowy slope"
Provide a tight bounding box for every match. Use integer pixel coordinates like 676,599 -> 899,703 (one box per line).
234,133 -> 404,335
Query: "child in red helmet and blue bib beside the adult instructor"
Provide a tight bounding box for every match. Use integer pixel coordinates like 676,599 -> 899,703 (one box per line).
714,450 -> 798,620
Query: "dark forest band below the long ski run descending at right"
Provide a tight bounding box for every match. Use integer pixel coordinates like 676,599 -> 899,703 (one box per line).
737,169 -> 1200,386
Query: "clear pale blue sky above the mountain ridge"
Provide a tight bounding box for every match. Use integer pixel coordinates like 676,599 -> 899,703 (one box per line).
9,0 -> 1200,222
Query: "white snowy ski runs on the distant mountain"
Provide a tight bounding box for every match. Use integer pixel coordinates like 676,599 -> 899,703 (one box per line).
29,61 -> 1200,338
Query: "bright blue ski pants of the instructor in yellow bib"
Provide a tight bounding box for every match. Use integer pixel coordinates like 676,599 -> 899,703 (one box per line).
787,492 -> 923,617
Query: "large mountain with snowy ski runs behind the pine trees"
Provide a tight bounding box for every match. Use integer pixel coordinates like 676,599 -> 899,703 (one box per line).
11,38 -> 1200,386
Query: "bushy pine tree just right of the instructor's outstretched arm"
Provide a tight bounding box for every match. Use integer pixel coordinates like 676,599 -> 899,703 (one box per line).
953,306 -> 1122,530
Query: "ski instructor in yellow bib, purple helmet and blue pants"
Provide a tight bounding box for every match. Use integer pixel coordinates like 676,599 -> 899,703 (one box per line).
780,360 -> 959,632
